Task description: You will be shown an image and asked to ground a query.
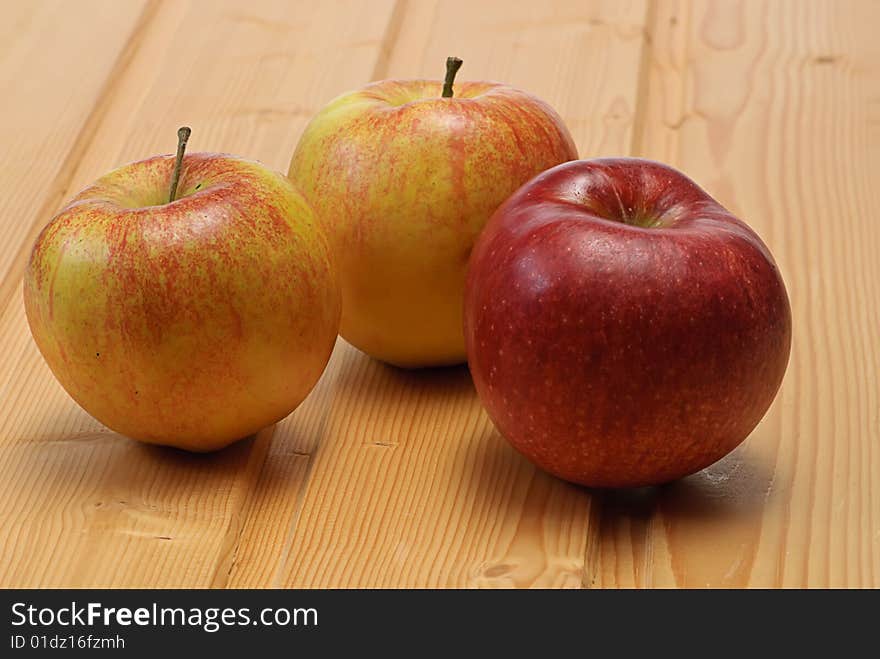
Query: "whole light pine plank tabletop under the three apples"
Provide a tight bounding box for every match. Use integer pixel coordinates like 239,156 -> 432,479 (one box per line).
0,0 -> 880,588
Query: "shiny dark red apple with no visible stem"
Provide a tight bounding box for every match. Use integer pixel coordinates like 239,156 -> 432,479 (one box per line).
464,158 -> 791,487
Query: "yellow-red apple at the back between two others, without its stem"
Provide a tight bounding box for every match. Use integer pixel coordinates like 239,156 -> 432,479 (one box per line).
289,80 -> 577,367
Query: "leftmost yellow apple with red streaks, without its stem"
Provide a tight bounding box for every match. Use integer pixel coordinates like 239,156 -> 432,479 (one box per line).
24,153 -> 341,451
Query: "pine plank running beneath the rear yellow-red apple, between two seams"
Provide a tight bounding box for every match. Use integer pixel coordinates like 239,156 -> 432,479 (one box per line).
223,1 -> 646,587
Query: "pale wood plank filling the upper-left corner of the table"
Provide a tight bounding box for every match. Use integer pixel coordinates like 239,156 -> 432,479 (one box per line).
0,0 -> 155,309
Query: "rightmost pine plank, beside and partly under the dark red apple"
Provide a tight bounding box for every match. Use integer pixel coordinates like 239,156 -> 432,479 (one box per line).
596,1 -> 880,587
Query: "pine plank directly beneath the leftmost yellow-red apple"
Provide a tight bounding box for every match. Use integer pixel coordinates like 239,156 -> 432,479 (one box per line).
0,0 -> 394,587
